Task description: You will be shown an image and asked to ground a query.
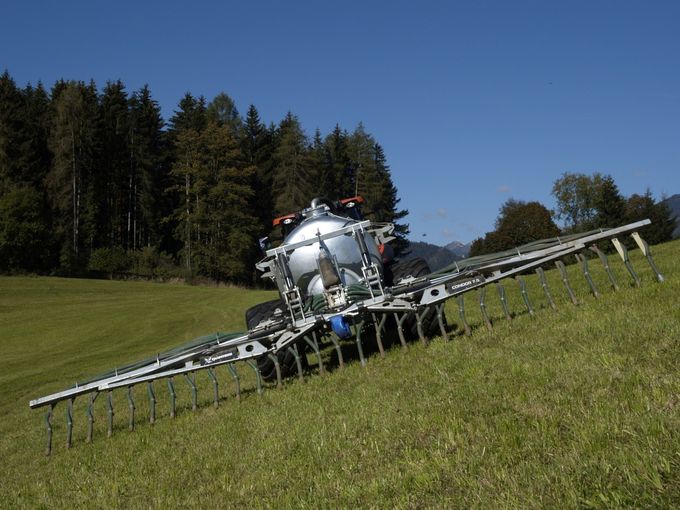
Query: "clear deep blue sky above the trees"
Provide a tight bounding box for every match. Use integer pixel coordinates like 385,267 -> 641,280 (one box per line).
0,0 -> 680,244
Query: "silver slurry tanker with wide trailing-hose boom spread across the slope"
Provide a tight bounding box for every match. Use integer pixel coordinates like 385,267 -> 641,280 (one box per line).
30,197 -> 663,454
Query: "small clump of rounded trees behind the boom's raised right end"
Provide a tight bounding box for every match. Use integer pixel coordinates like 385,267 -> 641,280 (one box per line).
470,172 -> 675,256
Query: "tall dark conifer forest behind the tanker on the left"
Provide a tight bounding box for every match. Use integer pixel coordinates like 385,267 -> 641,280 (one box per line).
0,71 -> 408,284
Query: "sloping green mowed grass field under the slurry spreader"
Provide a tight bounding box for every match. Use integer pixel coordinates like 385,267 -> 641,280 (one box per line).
0,242 -> 680,508
